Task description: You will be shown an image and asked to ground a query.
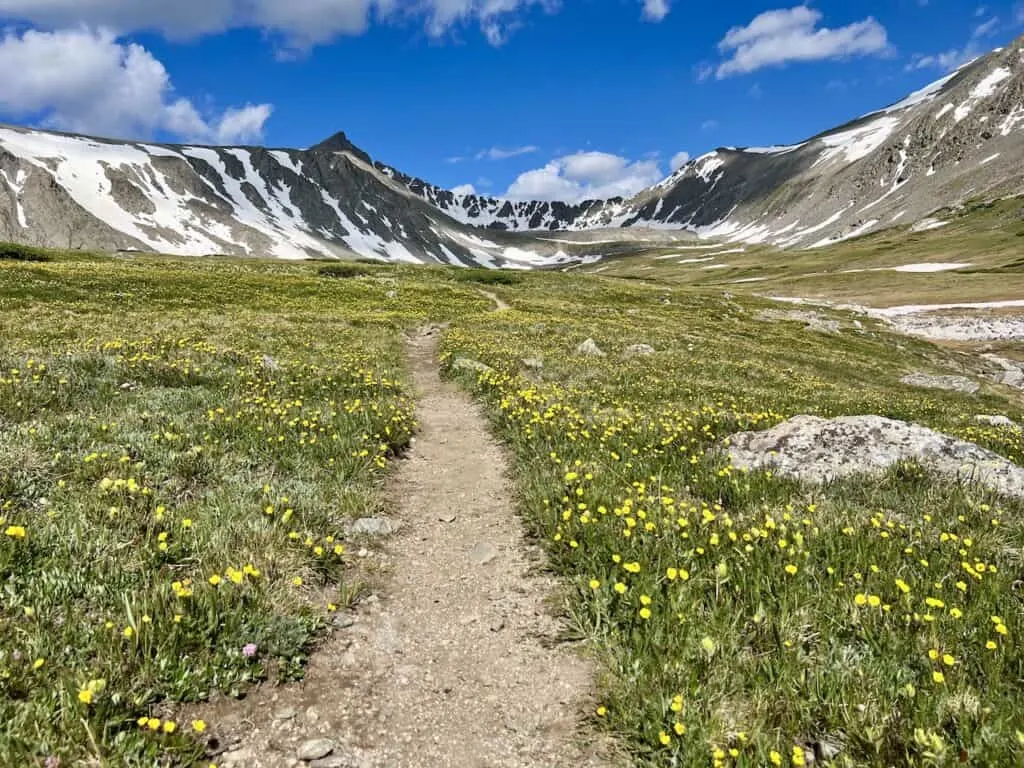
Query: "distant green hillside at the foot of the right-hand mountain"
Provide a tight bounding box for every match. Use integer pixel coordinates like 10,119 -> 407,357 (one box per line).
583,198 -> 1024,306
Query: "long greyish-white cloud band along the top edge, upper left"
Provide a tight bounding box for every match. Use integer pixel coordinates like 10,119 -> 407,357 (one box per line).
0,0 -> 565,50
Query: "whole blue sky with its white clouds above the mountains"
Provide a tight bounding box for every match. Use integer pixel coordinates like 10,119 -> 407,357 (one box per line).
0,0 -> 1024,199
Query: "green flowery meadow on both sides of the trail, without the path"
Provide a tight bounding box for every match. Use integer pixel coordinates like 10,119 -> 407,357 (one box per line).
0,247 -> 1024,766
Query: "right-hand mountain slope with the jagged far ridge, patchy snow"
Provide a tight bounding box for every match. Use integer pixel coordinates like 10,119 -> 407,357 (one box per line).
407,38 -> 1024,247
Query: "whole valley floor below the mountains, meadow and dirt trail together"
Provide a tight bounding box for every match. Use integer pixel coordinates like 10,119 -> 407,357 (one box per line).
0,218 -> 1024,768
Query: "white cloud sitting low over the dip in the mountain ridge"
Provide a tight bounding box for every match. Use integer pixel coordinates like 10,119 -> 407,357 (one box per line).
505,152 -> 665,203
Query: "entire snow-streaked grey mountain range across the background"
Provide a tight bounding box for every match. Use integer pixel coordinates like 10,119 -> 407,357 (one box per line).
0,38 -> 1024,268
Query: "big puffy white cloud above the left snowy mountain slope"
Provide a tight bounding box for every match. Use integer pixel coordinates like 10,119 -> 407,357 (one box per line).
0,29 -> 272,143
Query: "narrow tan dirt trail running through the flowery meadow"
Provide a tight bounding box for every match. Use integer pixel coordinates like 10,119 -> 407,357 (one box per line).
206,336 -> 606,768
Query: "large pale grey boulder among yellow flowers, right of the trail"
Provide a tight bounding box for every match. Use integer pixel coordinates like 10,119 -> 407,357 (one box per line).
727,416 -> 1024,497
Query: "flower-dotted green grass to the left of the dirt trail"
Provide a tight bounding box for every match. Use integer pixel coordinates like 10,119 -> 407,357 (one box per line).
0,249 -> 488,766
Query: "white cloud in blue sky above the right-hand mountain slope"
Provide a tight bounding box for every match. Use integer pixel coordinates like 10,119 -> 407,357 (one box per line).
716,5 -> 889,79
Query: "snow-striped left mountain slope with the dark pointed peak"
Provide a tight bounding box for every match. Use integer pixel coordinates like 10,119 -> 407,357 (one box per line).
0,127 -> 593,267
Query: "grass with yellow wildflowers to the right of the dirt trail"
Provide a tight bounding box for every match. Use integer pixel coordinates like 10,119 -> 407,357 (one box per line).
445,278 -> 1024,768
